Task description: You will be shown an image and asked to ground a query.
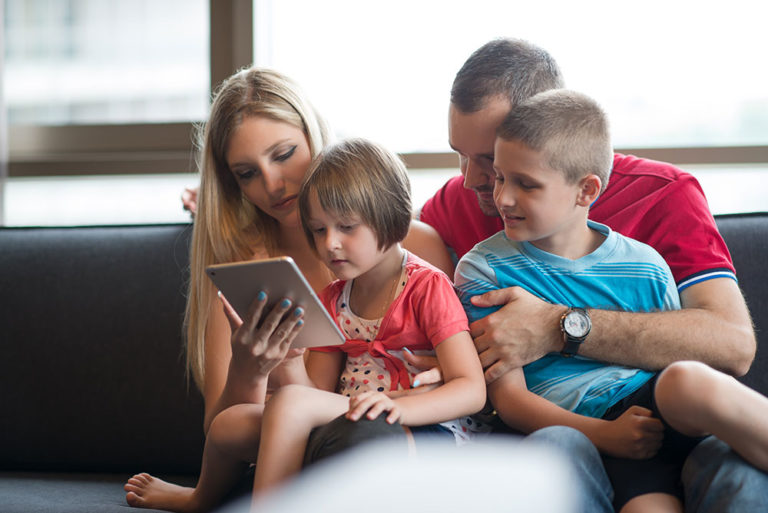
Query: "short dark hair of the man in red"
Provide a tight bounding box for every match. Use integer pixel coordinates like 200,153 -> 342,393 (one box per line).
451,39 -> 564,113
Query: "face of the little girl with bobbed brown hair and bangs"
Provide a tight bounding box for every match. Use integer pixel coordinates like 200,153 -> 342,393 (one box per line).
308,191 -> 387,280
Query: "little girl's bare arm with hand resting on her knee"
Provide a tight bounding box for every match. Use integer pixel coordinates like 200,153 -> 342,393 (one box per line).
347,331 -> 485,426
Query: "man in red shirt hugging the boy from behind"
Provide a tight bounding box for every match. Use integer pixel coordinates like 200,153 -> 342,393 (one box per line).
420,40 -> 768,511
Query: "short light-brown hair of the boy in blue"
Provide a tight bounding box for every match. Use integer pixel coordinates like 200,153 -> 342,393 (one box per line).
496,89 -> 613,189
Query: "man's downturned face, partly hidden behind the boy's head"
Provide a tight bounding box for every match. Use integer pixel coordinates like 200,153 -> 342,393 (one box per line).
448,98 -> 511,216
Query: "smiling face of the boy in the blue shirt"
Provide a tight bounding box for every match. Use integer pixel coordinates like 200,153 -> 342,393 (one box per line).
493,138 -> 586,256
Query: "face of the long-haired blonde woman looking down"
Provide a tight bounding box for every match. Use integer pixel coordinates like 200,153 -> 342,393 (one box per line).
227,116 -> 312,226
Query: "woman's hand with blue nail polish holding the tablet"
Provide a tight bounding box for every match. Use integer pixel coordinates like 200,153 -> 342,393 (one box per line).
219,293 -> 304,379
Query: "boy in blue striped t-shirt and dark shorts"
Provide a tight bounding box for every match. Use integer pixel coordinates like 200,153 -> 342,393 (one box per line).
456,89 -> 768,513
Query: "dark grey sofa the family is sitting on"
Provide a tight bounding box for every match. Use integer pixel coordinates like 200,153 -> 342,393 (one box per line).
0,213 -> 768,513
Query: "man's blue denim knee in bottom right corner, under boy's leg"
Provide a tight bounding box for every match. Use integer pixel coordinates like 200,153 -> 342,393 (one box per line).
682,436 -> 768,513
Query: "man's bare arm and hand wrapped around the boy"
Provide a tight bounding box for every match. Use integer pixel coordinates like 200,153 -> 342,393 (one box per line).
470,278 -> 756,382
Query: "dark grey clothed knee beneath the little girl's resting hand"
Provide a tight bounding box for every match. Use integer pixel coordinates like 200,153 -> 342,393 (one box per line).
304,415 -> 408,465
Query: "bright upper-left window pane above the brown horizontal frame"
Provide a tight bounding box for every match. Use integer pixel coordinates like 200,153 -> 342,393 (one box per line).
4,0 -> 210,125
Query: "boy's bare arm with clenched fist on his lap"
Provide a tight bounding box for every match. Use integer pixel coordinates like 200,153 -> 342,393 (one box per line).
488,368 -> 664,459
